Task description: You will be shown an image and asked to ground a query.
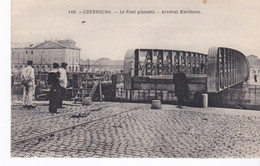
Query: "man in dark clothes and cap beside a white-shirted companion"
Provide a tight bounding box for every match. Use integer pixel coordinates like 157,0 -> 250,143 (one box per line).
48,63 -> 61,113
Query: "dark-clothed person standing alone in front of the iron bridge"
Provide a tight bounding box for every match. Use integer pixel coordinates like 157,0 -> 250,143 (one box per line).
173,66 -> 189,109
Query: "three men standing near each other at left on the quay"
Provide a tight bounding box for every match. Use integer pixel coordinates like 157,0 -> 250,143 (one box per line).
21,61 -> 68,113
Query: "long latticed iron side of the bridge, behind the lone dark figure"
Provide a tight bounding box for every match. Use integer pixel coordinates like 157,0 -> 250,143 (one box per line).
124,49 -> 208,76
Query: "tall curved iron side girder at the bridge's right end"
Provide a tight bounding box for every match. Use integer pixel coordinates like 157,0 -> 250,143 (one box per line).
207,47 -> 249,93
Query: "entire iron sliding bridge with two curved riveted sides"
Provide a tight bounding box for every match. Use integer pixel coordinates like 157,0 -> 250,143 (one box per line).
124,47 -> 249,100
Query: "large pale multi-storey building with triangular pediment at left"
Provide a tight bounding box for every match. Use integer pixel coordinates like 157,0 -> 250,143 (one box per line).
11,40 -> 80,72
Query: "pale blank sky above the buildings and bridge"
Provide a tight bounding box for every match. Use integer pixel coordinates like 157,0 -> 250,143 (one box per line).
11,0 -> 260,60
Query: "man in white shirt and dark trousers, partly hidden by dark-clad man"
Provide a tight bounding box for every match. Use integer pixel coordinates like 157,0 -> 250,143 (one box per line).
58,62 -> 68,108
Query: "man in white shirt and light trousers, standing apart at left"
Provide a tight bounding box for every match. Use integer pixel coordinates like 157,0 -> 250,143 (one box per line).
21,61 -> 36,108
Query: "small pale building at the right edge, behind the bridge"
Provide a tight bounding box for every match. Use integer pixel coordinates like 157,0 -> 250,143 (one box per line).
247,55 -> 260,79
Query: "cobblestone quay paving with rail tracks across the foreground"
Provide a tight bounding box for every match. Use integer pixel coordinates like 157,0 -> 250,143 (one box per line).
11,102 -> 260,158
